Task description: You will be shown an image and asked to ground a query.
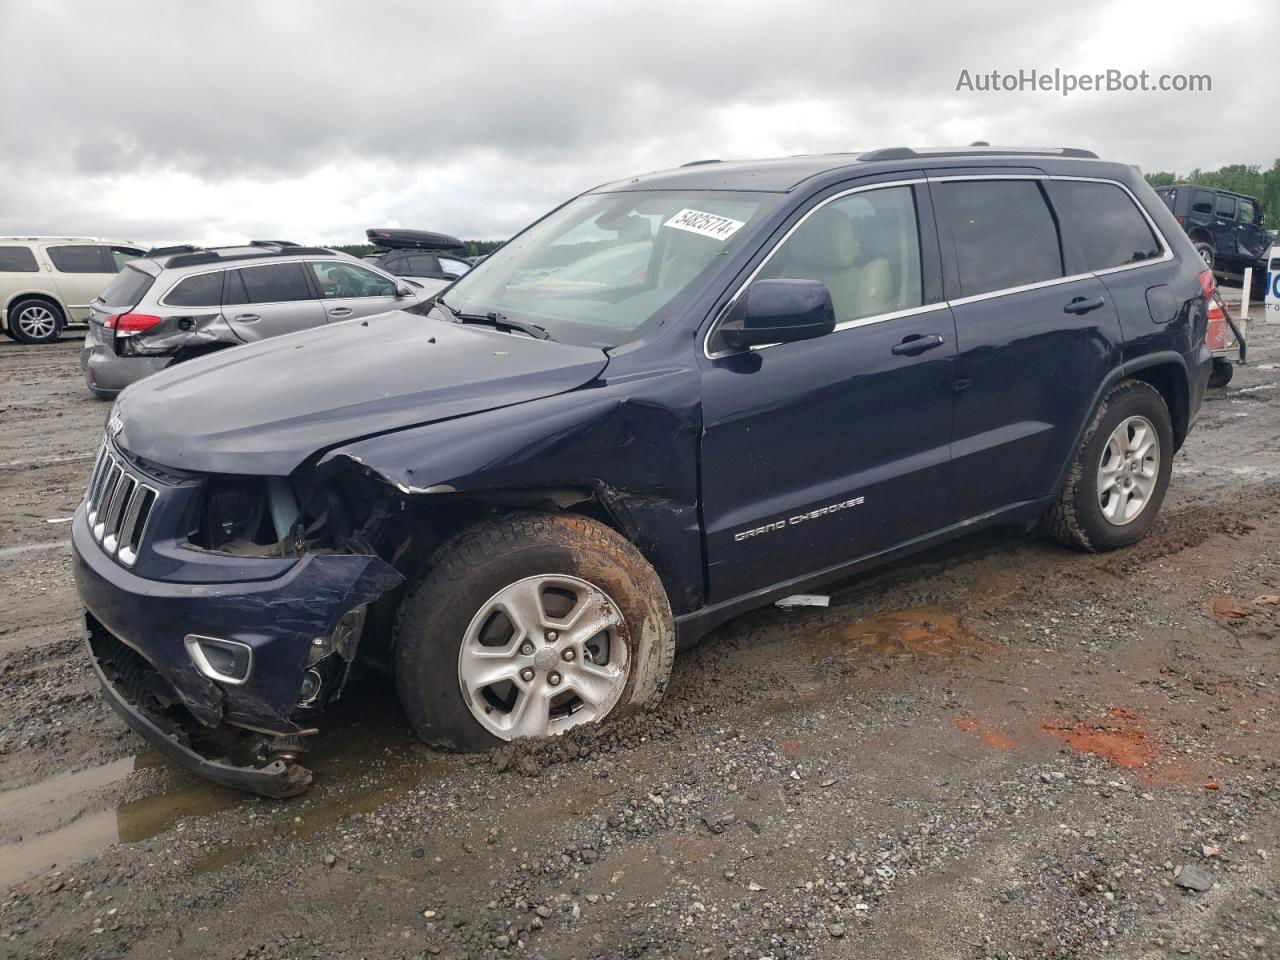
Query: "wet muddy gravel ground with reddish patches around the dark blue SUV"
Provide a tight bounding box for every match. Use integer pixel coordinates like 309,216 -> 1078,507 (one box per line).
0,309 -> 1280,960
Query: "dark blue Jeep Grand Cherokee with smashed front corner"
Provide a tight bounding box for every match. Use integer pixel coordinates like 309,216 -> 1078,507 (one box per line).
73,147 -> 1212,796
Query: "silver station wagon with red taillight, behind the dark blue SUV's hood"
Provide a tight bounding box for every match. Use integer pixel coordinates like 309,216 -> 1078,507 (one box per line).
81,248 -> 444,399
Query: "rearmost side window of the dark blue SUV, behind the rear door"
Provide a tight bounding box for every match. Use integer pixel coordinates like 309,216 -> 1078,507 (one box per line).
1048,180 -> 1162,271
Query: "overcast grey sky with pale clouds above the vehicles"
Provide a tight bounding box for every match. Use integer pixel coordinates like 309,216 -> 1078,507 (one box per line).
0,0 -> 1280,243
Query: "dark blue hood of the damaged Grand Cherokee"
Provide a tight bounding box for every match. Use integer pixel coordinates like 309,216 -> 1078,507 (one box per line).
111,311 -> 608,476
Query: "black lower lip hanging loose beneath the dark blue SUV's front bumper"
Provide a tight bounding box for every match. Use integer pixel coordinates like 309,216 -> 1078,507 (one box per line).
86,637 -> 311,800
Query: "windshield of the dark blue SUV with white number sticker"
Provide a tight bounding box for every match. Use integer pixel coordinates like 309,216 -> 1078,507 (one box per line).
442,191 -> 778,347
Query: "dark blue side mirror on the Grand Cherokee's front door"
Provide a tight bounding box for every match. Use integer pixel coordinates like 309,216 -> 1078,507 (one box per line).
719,280 -> 836,349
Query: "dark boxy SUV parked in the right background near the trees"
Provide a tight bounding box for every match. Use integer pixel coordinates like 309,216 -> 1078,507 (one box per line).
1156,183 -> 1272,296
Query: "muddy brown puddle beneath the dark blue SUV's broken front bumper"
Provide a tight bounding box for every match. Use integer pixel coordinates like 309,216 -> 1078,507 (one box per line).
0,684 -> 458,886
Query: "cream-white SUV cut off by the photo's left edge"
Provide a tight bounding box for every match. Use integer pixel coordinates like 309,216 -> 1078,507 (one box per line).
0,237 -> 142,343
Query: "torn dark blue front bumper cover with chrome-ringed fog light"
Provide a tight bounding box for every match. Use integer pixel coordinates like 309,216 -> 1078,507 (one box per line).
72,504 -> 402,796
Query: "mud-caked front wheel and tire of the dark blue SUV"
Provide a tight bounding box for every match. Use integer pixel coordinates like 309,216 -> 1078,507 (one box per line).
393,513 -> 676,750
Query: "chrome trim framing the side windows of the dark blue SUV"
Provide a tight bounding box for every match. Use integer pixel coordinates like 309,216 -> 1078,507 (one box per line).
703,174 -> 1174,360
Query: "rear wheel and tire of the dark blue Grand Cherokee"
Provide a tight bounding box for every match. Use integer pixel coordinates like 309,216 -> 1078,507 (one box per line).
1043,380 -> 1174,552
